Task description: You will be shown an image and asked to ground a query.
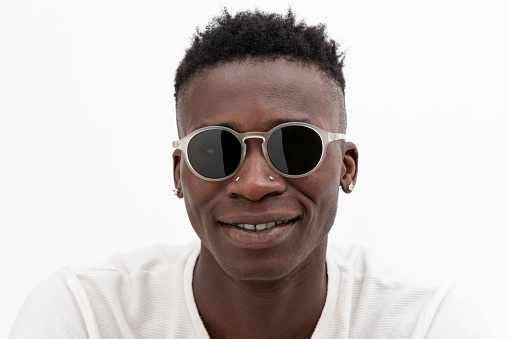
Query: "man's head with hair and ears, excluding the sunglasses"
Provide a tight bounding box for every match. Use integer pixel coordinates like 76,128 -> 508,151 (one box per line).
174,12 -> 357,280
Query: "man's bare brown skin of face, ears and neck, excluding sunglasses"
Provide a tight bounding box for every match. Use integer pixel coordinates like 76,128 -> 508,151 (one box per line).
173,59 -> 358,338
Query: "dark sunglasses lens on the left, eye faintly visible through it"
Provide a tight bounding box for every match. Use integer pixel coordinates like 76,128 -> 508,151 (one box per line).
187,129 -> 242,179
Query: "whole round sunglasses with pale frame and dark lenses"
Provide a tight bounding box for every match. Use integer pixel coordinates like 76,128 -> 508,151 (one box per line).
172,122 -> 346,181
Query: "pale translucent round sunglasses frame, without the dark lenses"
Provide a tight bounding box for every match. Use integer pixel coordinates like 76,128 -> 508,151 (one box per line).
172,122 -> 346,181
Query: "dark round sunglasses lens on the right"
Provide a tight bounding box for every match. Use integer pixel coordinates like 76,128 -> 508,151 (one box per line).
267,126 -> 323,175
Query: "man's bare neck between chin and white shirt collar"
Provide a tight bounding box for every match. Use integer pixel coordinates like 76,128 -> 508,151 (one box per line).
193,244 -> 327,338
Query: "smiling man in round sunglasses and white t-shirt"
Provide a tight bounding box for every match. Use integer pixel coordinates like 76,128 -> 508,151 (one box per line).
11,11 -> 488,338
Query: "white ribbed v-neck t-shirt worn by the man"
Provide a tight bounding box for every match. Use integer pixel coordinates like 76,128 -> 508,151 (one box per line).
10,243 -> 490,339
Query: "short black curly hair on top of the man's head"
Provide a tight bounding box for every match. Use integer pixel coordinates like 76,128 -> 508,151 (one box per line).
174,9 -> 345,100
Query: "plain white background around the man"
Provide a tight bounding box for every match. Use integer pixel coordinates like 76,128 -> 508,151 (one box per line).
0,0 -> 509,338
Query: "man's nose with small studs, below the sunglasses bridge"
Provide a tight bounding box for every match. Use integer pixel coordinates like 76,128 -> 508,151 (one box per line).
226,139 -> 286,201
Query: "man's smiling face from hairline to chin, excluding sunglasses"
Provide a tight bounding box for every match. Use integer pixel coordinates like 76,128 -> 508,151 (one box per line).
174,59 -> 348,280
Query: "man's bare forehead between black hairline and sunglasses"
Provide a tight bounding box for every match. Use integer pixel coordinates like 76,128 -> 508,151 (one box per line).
177,59 -> 344,136
